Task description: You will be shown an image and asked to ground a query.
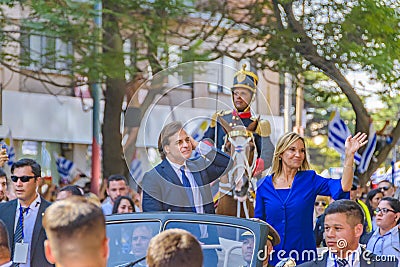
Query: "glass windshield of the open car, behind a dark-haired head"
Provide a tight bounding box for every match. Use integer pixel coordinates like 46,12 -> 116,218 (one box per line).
107,220 -> 254,267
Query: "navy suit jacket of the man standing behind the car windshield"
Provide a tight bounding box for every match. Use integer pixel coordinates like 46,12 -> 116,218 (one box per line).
142,148 -> 230,213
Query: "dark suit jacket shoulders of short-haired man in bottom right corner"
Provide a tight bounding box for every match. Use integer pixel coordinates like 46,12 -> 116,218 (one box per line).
298,248 -> 398,267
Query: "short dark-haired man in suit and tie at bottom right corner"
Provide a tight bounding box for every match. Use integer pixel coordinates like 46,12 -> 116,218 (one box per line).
299,199 -> 398,267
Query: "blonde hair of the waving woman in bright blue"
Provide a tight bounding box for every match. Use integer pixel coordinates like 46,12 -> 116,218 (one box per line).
271,132 -> 310,177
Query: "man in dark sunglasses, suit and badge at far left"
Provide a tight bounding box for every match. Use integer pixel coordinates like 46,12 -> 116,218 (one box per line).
0,159 -> 53,267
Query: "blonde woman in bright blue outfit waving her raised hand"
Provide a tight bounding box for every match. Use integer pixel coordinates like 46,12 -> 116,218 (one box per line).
255,132 -> 368,265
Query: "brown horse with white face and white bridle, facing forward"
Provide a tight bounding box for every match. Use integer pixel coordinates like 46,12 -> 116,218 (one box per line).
216,118 -> 258,218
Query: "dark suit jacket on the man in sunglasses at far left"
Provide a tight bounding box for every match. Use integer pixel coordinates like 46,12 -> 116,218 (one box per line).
0,198 -> 54,267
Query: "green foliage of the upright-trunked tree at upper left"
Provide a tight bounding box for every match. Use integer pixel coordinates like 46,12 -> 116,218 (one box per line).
0,0 -> 202,86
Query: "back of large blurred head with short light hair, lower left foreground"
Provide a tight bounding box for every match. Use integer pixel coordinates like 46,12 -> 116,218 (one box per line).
43,196 -> 108,266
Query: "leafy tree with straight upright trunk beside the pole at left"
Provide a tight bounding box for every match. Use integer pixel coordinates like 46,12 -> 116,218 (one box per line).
0,0 -> 196,184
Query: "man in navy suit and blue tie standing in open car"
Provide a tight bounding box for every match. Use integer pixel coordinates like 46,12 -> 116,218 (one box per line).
142,122 -> 230,213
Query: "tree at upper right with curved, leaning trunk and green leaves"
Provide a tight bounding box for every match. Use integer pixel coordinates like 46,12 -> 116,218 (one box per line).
181,0 -> 400,186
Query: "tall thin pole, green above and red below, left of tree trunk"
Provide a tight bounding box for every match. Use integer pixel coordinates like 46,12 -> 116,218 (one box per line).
90,0 -> 102,195
